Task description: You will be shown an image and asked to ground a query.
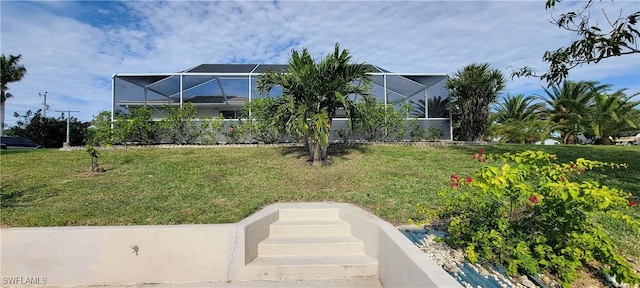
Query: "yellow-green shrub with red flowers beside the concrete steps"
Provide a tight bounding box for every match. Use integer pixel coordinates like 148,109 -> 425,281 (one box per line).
432,150 -> 640,286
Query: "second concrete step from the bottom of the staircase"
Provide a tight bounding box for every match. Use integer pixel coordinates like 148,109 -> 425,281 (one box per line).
258,235 -> 364,256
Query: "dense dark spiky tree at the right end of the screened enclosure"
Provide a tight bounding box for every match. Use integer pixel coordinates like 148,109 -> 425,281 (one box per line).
447,63 -> 505,141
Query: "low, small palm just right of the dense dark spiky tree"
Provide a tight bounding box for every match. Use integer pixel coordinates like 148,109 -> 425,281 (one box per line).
490,94 -> 550,143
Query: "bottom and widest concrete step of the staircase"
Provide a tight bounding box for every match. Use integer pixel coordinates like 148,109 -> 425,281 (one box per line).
247,255 -> 378,280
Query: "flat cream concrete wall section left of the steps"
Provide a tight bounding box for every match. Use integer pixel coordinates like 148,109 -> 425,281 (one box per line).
0,225 -> 238,286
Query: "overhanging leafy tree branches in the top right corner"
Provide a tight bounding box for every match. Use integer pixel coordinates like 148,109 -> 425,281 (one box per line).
512,0 -> 640,85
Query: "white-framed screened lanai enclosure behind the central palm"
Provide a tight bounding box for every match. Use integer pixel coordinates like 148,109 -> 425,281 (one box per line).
111,64 -> 452,141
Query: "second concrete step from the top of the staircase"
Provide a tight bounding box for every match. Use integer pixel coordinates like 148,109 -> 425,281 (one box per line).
269,219 -> 351,237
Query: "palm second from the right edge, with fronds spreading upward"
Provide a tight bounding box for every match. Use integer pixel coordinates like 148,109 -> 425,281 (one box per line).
540,80 -> 607,144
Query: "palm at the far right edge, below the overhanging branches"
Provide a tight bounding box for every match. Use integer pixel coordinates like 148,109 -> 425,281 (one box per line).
588,86 -> 640,144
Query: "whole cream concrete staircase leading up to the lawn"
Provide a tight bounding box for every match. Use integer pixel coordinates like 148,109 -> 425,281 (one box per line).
247,209 -> 378,279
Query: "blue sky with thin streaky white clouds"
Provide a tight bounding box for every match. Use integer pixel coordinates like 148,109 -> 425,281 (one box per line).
0,0 -> 640,127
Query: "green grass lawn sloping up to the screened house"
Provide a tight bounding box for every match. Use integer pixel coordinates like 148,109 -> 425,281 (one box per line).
0,145 -> 640,256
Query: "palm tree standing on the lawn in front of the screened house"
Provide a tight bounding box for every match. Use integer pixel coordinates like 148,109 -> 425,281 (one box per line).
256,43 -> 373,162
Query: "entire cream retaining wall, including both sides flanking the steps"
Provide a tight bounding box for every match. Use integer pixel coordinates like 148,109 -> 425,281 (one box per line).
0,203 -> 460,287
